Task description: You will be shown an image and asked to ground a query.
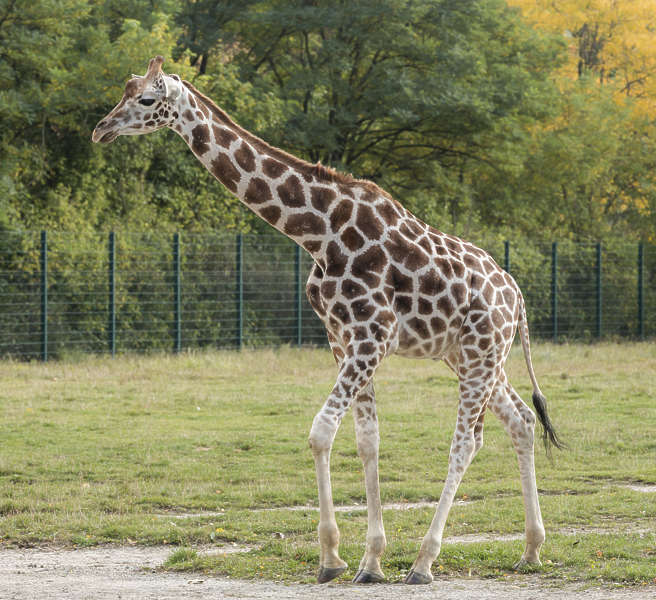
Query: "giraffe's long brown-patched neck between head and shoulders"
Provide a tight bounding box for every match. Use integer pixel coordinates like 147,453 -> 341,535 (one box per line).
171,82 -> 340,255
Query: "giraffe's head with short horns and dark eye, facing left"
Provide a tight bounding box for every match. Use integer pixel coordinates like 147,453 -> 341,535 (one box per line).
91,56 -> 183,144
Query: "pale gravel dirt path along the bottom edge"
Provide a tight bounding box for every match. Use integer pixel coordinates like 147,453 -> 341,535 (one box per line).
0,546 -> 656,600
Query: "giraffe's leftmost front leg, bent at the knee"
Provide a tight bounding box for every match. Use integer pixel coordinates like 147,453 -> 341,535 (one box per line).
309,352 -> 382,583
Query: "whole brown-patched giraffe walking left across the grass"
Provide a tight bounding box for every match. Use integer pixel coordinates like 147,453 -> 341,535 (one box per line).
92,56 -> 562,584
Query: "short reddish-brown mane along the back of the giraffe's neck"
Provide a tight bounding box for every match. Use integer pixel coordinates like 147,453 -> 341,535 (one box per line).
182,80 -> 389,196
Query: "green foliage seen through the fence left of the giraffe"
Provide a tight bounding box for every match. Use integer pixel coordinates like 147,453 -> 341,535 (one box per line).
0,230 -> 336,359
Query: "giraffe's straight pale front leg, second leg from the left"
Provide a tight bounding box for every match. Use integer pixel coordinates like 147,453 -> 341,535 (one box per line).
353,382 -> 387,583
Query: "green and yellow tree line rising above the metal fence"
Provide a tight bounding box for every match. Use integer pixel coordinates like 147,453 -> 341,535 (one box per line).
0,0 -> 656,241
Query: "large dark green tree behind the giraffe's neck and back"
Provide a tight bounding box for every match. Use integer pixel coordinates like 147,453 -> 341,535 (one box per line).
222,0 -> 559,204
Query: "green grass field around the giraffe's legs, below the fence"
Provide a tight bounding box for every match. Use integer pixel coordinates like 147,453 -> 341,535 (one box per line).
0,343 -> 656,584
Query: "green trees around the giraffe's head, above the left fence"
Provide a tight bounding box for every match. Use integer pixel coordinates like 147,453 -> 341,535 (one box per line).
0,0 -> 266,231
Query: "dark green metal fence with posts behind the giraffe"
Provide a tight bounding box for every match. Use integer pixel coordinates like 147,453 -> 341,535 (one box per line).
0,232 -> 656,360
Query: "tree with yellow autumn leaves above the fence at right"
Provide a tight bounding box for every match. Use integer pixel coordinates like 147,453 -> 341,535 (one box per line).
502,0 -> 656,239
